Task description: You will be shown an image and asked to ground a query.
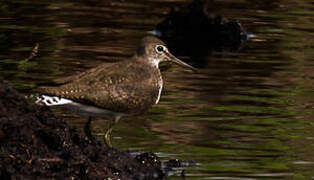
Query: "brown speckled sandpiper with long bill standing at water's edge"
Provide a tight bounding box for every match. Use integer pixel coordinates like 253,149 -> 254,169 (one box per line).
36,36 -> 197,147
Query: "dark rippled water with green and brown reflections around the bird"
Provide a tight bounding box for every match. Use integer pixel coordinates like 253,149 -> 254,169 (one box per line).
0,0 -> 314,179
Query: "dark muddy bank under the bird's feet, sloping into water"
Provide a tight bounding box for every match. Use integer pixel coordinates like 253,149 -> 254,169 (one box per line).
0,80 -> 163,179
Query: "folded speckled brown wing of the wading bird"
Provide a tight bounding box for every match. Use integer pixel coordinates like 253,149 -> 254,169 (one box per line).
40,63 -> 157,113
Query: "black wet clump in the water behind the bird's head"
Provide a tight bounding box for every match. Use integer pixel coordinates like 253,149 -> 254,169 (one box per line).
155,0 -> 248,60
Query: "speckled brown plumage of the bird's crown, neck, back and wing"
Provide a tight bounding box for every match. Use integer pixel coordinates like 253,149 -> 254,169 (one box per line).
39,37 -> 164,114
